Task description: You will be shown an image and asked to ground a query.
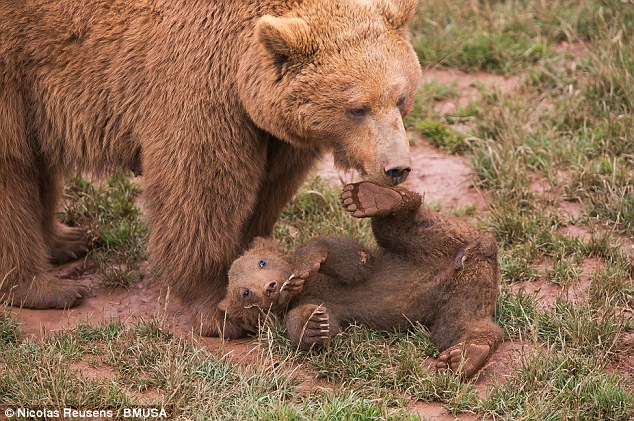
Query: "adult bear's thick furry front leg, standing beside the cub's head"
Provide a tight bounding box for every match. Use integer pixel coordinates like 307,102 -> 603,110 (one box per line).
142,120 -> 266,337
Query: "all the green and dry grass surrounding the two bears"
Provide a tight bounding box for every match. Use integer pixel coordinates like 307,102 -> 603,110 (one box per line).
0,0 -> 634,420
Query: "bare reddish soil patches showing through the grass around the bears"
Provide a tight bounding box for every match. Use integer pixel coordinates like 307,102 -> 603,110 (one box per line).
3,70 -> 632,421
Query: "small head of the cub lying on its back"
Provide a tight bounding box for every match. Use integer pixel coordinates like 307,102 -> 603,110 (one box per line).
218,237 -> 292,327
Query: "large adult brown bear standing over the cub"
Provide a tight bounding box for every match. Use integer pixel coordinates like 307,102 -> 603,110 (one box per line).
0,0 -> 421,334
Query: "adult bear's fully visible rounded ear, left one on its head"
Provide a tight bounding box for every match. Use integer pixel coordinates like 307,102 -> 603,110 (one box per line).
255,15 -> 315,64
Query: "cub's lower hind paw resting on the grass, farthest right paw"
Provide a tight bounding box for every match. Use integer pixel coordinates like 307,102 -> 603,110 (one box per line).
436,342 -> 492,378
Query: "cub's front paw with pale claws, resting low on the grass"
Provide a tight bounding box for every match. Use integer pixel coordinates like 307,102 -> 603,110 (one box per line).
286,304 -> 340,350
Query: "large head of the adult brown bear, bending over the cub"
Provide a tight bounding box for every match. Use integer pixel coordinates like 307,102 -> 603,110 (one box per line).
238,0 -> 421,185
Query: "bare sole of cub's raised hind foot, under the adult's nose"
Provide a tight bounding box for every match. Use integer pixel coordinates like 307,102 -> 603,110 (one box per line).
341,182 -> 402,218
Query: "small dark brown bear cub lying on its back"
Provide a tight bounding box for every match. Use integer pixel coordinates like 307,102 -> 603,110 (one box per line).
221,182 -> 502,377
